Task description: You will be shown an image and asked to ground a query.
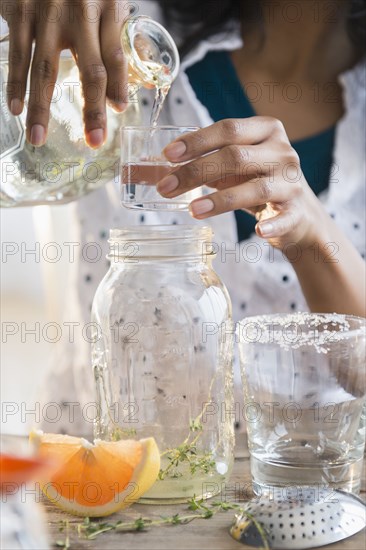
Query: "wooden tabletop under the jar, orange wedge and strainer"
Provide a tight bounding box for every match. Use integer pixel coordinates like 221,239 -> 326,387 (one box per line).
43,449 -> 366,550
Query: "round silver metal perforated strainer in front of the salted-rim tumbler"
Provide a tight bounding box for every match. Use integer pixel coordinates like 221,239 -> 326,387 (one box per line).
230,489 -> 366,550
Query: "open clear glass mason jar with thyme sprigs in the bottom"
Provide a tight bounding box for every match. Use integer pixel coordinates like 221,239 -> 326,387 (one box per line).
92,225 -> 234,502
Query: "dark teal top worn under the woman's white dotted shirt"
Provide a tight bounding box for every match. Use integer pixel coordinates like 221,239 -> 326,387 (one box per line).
186,51 -> 335,241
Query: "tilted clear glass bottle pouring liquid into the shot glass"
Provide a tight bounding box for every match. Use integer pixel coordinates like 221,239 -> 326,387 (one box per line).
0,16 -> 179,207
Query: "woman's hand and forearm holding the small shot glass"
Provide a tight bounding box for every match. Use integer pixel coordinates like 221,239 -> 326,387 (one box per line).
158,117 -> 366,316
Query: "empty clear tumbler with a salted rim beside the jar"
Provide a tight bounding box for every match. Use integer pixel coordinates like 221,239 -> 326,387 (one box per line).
237,313 -> 366,494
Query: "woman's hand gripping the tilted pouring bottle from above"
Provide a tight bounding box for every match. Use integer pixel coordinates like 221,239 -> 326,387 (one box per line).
0,0 -> 129,147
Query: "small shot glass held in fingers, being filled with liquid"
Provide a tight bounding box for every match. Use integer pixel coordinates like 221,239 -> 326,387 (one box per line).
121,126 -> 202,210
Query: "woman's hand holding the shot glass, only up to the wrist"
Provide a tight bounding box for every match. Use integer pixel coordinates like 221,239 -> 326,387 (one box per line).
157,117 -> 321,252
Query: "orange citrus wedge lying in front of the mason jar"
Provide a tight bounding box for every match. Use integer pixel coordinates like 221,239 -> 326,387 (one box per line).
30,431 -> 160,517
